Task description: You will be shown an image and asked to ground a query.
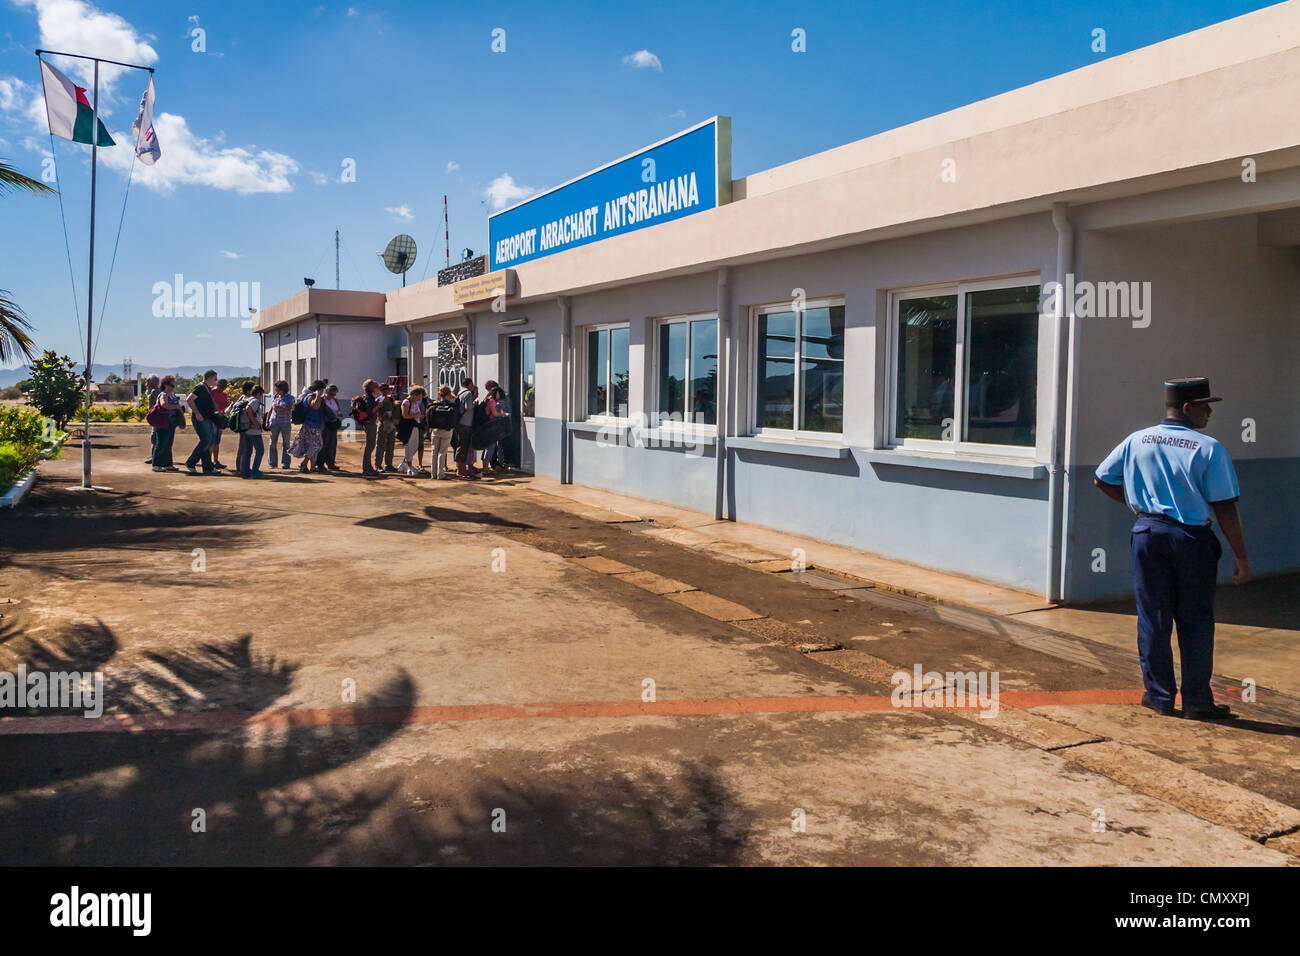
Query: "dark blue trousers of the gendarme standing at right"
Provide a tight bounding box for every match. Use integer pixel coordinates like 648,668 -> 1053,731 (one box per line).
1130,518 -> 1223,710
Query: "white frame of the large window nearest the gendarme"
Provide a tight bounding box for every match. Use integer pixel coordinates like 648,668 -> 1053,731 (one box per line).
884,272 -> 1044,460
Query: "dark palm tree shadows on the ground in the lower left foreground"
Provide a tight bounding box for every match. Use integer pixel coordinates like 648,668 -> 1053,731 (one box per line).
0,623 -> 751,865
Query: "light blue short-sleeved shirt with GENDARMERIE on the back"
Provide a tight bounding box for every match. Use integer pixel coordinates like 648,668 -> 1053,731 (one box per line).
1097,419 -> 1240,524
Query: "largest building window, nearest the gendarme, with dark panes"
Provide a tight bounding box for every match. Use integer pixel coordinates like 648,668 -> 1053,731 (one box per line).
892,282 -> 1040,453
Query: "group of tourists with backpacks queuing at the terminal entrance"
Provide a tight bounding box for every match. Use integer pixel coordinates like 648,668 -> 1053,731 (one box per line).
146,369 -> 511,480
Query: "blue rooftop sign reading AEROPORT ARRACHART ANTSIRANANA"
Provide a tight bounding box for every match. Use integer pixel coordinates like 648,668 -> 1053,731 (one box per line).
488,116 -> 731,269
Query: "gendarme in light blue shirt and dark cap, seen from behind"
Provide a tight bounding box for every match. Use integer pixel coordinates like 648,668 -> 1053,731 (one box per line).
1093,378 -> 1251,719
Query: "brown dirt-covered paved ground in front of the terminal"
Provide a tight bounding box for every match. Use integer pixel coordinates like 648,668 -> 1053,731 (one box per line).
0,425 -> 1300,865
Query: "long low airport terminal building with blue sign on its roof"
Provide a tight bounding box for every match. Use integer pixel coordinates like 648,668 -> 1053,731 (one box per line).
254,4 -> 1300,602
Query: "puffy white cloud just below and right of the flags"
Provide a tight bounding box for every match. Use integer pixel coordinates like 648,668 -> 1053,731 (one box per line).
99,113 -> 298,195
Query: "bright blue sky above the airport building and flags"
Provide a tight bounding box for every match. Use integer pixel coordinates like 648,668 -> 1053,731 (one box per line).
0,0 -> 1269,365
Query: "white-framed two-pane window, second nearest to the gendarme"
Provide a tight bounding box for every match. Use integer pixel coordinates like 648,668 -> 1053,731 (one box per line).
754,302 -> 844,434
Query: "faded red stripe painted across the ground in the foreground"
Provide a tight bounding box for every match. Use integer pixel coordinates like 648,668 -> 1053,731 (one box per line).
0,688 -> 1141,735
